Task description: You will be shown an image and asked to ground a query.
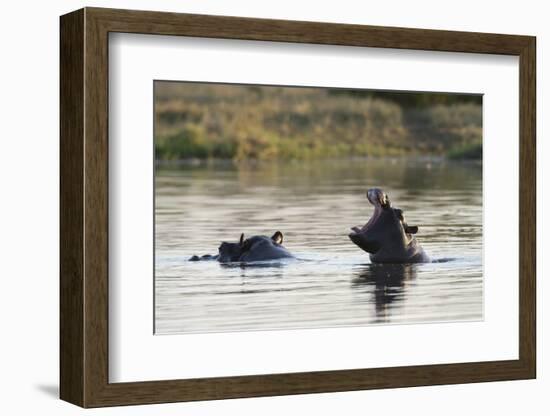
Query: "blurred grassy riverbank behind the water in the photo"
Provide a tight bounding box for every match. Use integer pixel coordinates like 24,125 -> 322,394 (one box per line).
155,81 -> 482,161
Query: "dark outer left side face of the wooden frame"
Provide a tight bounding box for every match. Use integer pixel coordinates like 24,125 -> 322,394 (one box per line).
59,10 -> 86,406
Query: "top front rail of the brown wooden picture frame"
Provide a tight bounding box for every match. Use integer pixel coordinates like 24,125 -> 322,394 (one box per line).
90,8 -> 529,55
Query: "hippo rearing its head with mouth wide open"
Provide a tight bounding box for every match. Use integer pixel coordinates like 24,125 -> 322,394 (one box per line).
349,188 -> 430,263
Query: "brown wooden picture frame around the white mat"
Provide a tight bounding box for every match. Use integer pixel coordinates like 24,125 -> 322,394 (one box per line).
60,8 -> 536,407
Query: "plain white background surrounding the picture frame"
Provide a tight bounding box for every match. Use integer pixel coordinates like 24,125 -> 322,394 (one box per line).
0,0 -> 550,416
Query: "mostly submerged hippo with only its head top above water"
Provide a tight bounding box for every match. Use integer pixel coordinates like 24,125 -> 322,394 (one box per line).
189,231 -> 294,263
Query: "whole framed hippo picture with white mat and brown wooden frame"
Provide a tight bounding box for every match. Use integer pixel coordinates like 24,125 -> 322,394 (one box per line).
60,8 -> 536,407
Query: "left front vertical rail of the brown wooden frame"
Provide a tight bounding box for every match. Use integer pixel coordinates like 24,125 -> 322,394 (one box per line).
84,11 -> 109,406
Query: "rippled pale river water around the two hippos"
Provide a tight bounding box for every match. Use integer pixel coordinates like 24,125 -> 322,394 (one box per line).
155,159 -> 483,334
